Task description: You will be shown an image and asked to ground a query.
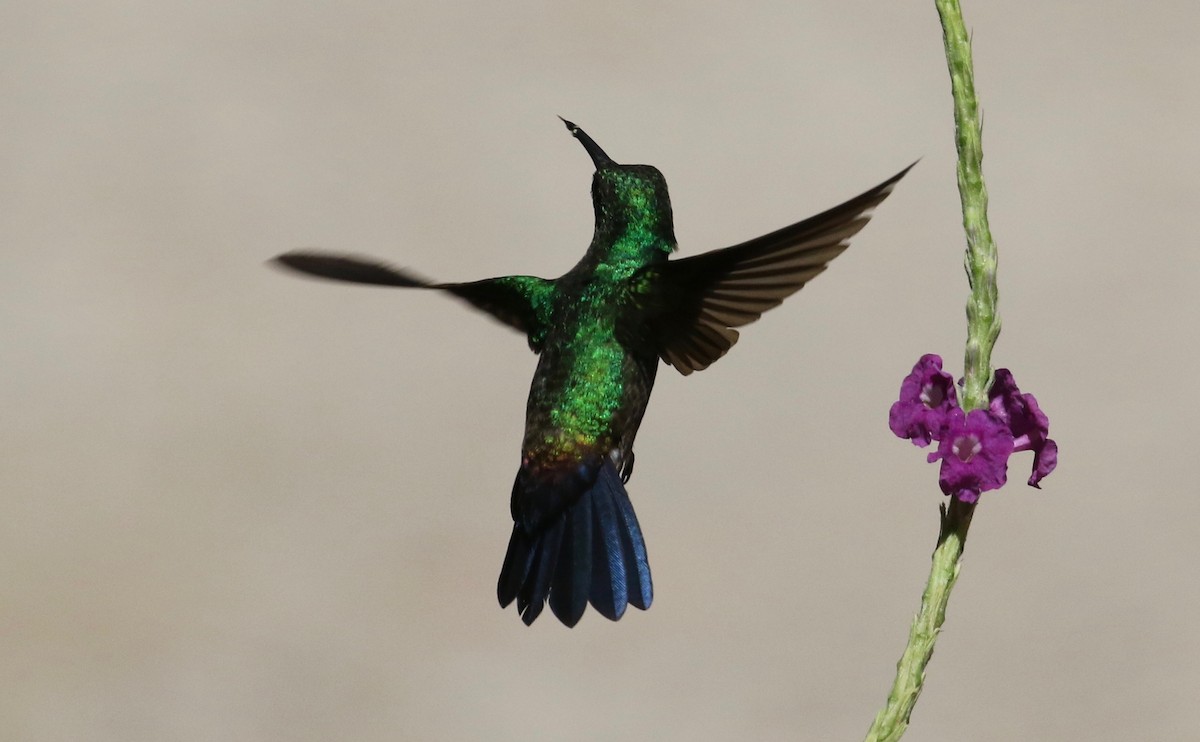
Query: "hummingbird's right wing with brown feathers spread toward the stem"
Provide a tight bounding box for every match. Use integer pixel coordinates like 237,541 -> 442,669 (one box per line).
630,163 -> 916,376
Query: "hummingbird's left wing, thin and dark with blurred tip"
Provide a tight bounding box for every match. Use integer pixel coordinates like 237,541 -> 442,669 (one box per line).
274,251 -> 554,351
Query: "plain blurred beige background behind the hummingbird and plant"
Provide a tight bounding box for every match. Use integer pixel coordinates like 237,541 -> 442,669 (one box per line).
0,0 -> 1200,742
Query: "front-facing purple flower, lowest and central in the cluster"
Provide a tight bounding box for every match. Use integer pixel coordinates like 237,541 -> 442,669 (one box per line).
929,408 -> 1013,502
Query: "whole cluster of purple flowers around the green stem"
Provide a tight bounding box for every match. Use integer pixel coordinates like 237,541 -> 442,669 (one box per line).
888,354 -> 1058,502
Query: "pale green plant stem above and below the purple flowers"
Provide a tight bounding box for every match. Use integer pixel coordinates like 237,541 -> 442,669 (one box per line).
866,0 -> 1000,742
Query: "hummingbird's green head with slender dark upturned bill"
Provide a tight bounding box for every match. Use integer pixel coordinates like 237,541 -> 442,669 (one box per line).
559,116 -> 676,252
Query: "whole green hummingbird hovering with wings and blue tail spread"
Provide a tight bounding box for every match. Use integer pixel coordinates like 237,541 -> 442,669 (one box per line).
275,119 -> 916,627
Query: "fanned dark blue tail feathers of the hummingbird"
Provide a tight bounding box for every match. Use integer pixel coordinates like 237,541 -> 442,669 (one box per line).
497,456 -> 654,627
